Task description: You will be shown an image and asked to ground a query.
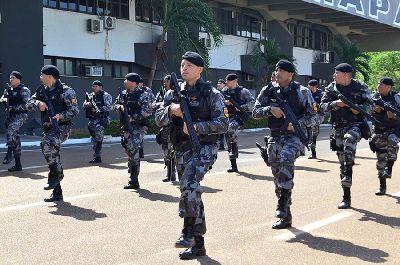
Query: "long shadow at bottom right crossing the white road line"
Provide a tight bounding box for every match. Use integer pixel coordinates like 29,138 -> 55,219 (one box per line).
287,228 -> 389,263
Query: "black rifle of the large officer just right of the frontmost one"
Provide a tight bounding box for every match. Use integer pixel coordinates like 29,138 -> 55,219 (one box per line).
272,86 -> 310,150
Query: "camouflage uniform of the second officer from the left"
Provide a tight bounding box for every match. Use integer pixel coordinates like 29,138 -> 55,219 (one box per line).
26,80 -> 79,198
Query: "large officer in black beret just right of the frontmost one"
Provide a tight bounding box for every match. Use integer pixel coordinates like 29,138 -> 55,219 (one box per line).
253,60 -> 313,229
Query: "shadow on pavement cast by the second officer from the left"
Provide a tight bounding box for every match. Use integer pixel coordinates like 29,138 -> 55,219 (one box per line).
50,201 -> 107,221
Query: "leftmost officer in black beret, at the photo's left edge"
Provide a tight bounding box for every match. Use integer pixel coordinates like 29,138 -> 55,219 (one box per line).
0,71 -> 31,172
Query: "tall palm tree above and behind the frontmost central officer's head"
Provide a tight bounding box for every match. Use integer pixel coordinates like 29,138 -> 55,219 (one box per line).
147,0 -> 222,87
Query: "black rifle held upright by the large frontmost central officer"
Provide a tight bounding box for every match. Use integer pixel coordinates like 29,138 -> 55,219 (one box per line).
171,73 -> 201,153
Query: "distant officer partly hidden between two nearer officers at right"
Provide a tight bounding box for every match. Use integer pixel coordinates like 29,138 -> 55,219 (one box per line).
307,79 -> 324,159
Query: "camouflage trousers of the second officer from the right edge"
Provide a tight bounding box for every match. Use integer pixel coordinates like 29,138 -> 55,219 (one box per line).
335,123 -> 361,179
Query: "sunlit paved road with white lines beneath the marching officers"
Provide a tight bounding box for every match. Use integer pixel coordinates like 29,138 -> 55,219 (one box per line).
0,129 -> 400,264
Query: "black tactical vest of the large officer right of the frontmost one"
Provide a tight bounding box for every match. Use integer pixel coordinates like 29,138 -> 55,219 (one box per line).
265,82 -> 306,132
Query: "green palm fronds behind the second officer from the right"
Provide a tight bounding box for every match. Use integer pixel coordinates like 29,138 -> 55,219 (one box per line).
333,35 -> 370,82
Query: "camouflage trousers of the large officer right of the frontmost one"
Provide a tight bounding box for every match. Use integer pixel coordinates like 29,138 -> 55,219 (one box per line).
267,134 -> 305,193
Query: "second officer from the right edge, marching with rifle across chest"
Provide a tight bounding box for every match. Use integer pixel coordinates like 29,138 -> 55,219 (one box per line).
320,63 -> 371,209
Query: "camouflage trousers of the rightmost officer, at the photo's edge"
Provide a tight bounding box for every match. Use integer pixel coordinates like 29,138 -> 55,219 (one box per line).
371,131 -> 400,176
